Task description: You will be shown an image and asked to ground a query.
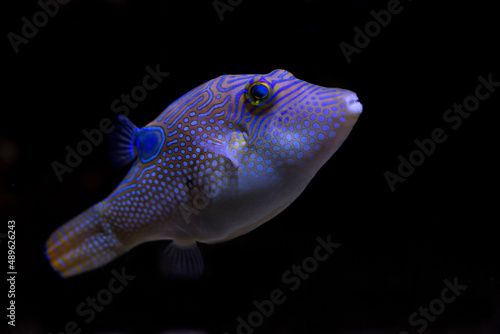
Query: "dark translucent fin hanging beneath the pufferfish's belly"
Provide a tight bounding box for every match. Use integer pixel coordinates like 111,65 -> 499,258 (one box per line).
160,242 -> 205,279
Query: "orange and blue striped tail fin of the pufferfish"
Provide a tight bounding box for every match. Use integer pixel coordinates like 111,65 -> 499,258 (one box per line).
45,203 -> 126,278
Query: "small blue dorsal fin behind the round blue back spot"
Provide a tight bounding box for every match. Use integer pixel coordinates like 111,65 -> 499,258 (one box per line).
108,115 -> 139,168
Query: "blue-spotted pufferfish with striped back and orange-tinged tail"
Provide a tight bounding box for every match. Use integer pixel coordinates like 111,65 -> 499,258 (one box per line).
46,70 -> 362,278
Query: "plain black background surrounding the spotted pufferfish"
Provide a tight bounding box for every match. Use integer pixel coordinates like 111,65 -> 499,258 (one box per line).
0,0 -> 500,334
